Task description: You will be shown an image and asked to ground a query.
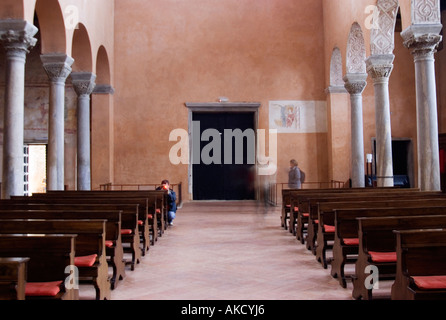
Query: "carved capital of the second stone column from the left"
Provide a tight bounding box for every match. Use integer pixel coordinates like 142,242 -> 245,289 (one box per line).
40,53 -> 74,83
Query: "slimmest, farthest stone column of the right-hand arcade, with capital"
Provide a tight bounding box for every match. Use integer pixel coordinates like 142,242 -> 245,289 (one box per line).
344,73 -> 367,188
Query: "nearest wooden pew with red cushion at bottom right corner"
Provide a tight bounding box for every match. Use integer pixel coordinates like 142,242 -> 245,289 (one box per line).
391,229 -> 446,300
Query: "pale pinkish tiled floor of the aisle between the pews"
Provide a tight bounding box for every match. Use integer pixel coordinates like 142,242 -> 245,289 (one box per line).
81,201 -> 351,300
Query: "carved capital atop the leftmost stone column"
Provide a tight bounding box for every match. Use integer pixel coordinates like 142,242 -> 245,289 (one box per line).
0,19 -> 38,58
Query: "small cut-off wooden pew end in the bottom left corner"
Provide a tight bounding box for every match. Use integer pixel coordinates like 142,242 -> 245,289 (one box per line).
0,257 -> 29,300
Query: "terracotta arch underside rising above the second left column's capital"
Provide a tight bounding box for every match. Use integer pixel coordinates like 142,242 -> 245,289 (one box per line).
35,0 -> 67,54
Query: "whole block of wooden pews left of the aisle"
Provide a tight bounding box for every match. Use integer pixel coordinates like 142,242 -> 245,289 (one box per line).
0,190 -> 168,300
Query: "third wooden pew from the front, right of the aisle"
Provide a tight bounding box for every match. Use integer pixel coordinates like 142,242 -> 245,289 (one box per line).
323,199 -> 446,288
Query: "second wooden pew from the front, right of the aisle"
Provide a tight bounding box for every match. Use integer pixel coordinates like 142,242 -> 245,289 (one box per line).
352,212 -> 446,300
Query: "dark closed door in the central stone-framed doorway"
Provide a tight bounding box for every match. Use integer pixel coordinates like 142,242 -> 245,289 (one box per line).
191,112 -> 256,200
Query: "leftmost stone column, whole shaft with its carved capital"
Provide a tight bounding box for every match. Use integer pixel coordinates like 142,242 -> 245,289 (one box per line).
0,20 -> 38,199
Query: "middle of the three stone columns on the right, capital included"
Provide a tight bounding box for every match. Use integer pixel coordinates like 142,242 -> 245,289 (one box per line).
366,54 -> 395,187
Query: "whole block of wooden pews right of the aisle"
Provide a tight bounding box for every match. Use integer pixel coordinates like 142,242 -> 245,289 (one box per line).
281,188 -> 446,300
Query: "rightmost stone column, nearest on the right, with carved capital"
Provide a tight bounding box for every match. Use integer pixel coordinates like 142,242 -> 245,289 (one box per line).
401,25 -> 442,191
